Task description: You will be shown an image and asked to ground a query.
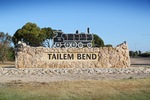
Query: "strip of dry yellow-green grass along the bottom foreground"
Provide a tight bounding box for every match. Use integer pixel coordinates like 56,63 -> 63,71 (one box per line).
0,78 -> 150,100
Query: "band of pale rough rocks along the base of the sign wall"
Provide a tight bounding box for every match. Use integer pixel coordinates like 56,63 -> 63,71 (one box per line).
0,68 -> 150,77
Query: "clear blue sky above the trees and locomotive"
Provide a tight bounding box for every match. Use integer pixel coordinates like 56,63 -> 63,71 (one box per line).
0,0 -> 150,52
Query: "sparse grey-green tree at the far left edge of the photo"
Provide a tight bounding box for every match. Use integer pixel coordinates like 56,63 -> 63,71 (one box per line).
0,32 -> 12,62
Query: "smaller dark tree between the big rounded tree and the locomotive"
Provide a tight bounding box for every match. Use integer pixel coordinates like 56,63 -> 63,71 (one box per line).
41,27 -> 54,48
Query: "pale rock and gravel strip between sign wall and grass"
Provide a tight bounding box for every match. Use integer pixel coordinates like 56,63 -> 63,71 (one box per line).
0,67 -> 150,82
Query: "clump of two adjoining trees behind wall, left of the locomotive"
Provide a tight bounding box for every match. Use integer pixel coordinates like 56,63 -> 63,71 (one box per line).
12,22 -> 54,47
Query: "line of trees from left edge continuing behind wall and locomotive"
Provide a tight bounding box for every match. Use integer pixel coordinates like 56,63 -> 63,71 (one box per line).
0,22 -> 105,62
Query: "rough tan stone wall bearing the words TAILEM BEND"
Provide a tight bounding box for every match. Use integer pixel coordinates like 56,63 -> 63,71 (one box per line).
16,43 -> 130,68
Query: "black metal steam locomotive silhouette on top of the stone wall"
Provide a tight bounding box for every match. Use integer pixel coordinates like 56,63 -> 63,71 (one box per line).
53,28 -> 93,48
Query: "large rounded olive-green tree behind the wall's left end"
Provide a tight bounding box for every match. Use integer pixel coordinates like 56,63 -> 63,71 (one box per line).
12,22 -> 46,46
